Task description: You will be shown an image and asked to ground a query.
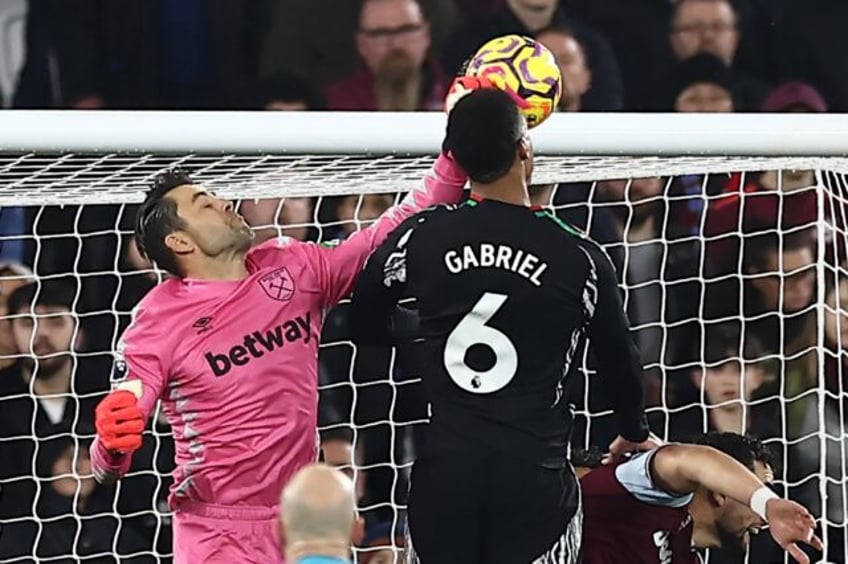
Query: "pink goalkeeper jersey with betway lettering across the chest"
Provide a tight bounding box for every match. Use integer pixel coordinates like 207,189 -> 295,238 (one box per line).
91,156 -> 466,510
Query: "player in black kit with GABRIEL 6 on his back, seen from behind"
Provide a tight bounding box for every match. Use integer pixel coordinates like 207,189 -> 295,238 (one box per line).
351,89 -> 652,564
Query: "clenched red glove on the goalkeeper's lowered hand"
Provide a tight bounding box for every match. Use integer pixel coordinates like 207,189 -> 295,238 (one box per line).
94,390 -> 144,454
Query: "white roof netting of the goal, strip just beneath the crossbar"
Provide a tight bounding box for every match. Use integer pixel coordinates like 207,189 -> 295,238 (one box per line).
0,153 -> 848,206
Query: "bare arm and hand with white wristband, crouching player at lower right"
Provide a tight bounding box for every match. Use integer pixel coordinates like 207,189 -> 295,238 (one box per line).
650,444 -> 822,563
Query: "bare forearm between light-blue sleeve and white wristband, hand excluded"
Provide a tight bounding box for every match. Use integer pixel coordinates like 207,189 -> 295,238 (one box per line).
651,444 -> 763,505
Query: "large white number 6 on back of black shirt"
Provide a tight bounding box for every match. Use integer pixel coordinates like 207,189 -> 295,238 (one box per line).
444,292 -> 518,394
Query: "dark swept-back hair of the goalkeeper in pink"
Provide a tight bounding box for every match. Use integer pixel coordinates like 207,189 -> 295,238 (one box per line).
135,167 -> 194,276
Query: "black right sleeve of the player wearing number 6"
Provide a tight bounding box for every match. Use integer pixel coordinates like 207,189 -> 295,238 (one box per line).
584,243 -> 649,444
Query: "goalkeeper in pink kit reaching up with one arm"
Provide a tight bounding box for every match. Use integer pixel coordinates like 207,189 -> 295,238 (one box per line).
91,101 -> 474,563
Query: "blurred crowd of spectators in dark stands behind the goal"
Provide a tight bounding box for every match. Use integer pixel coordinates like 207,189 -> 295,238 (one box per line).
0,0 -> 848,564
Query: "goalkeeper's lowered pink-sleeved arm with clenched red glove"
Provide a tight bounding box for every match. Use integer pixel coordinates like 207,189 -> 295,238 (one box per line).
90,307 -> 167,483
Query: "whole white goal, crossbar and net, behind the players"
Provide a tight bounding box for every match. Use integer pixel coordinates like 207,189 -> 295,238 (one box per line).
0,112 -> 848,563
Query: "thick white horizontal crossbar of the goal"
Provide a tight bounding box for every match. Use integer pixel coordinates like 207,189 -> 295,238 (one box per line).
0,110 -> 848,157
